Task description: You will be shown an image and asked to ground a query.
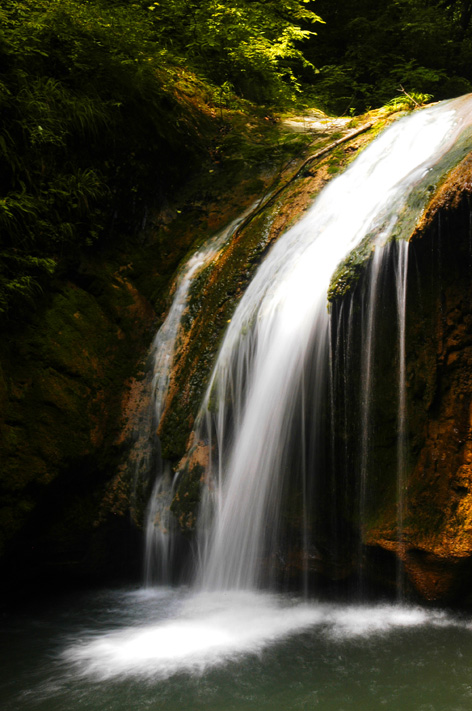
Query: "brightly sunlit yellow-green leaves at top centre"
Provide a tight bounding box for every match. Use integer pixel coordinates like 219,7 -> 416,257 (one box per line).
144,0 -> 320,102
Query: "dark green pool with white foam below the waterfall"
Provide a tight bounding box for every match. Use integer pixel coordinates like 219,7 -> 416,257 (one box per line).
0,589 -> 472,711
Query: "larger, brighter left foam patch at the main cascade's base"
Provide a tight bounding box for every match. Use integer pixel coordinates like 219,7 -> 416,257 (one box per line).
63,593 -> 321,680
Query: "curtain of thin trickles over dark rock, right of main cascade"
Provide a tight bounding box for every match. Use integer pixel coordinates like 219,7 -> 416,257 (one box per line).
330,240 -> 409,598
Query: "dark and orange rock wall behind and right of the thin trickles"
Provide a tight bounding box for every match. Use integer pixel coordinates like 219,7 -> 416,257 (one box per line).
161,138 -> 472,603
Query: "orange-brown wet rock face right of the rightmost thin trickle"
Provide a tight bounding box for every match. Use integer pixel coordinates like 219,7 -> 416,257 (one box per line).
362,165 -> 472,603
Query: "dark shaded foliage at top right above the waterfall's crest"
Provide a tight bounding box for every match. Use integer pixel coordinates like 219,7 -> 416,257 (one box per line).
305,0 -> 472,113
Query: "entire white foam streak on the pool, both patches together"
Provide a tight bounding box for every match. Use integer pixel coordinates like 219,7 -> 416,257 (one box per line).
62,591 -> 457,681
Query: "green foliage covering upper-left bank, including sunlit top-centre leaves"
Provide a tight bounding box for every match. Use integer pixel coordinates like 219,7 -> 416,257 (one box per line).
0,0 -> 319,318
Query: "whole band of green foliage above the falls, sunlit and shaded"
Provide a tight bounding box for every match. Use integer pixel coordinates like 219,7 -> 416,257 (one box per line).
0,0 -> 472,321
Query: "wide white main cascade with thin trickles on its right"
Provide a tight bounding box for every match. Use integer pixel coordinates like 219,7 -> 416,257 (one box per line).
190,96 -> 472,590
